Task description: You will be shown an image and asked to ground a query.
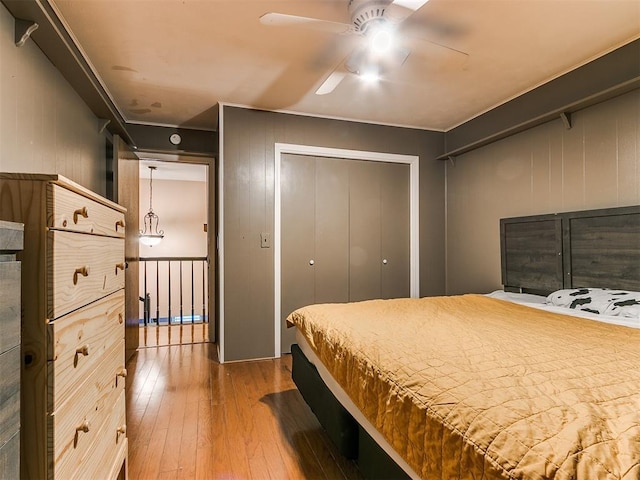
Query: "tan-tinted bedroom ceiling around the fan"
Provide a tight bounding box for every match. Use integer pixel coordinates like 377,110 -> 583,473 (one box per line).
50,0 -> 640,131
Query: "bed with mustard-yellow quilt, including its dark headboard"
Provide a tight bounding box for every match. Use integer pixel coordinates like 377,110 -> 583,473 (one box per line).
288,206 -> 640,479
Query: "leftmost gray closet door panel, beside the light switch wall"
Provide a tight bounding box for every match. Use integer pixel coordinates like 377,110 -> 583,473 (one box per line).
280,155 -> 315,352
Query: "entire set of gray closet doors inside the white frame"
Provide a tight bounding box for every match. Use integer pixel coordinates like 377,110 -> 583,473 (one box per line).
280,154 -> 410,352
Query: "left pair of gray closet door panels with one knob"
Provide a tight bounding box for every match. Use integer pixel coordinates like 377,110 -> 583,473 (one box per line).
280,155 -> 349,352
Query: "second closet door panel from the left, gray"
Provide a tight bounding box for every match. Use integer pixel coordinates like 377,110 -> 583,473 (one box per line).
314,157 -> 349,303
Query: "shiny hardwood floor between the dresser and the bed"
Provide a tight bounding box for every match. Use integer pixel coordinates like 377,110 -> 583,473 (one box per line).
127,343 -> 361,480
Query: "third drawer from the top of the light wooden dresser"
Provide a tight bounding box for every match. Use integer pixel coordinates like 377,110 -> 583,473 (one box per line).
48,290 -> 124,411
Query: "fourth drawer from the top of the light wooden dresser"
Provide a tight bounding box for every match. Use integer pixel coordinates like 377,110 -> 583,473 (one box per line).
49,340 -> 125,478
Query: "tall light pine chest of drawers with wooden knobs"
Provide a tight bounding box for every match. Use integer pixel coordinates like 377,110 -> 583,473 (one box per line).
0,173 -> 127,480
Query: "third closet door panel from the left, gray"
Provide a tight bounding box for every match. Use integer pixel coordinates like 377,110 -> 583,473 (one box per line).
349,160 -> 382,302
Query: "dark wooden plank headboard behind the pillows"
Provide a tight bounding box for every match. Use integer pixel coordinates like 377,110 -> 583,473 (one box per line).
500,205 -> 640,294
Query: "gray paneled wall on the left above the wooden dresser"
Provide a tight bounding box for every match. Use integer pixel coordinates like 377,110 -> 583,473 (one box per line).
0,4 -> 106,195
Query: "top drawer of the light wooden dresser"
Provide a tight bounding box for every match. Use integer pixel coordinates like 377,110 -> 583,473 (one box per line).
47,184 -> 125,238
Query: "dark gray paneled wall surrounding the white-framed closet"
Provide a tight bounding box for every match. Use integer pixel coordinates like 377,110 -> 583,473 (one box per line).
220,106 -> 445,361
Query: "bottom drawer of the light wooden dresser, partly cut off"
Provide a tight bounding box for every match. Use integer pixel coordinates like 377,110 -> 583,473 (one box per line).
73,392 -> 127,480
